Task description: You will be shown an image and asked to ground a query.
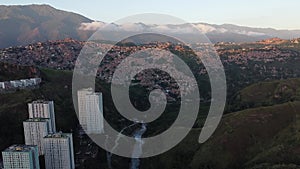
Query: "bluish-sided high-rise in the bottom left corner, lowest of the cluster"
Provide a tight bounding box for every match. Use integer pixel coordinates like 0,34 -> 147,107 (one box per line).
2,145 -> 40,169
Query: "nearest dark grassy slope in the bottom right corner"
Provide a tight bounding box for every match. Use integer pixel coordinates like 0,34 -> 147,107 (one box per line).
191,102 -> 300,169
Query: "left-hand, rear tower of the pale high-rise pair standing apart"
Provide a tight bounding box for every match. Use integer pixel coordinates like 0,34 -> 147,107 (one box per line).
77,88 -> 93,130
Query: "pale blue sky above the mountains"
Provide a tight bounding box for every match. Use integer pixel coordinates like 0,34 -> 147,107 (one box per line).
0,0 -> 300,29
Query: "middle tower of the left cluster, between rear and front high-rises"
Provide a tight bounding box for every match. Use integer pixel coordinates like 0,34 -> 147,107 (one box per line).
23,118 -> 53,155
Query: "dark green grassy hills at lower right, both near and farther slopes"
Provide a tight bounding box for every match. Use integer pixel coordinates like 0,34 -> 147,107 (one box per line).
143,79 -> 300,169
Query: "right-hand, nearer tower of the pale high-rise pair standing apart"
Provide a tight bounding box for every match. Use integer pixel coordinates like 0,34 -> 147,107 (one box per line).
86,93 -> 104,134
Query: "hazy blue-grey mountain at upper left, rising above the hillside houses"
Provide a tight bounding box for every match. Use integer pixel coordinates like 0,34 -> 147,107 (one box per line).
0,5 -> 91,48
